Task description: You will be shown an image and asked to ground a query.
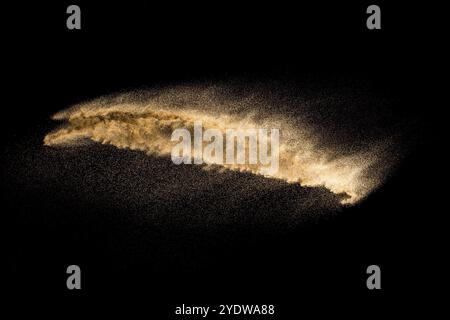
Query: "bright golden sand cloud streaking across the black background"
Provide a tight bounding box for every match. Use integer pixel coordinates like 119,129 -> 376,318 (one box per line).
44,88 -> 394,204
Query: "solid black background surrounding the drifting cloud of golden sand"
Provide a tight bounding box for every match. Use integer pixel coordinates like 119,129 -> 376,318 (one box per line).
2,1 -> 443,319
